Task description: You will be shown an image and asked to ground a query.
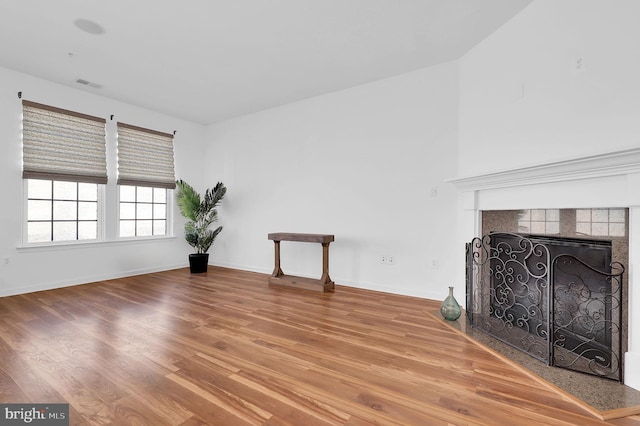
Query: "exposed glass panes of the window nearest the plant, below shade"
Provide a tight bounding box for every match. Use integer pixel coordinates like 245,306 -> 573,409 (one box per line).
119,185 -> 167,237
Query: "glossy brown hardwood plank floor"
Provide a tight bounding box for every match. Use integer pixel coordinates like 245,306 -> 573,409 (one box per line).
0,267 -> 640,426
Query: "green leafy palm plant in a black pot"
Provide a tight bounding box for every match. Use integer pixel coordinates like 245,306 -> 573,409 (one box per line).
176,180 -> 227,273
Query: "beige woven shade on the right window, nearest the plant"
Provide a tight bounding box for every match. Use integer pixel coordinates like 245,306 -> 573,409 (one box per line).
118,123 -> 176,189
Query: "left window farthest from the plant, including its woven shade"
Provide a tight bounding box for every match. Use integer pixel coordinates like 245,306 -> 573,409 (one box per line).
22,100 -> 107,243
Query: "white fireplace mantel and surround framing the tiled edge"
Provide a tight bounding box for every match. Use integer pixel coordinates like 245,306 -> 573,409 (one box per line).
450,148 -> 640,390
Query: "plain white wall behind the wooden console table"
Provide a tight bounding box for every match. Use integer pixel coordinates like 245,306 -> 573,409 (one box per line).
207,63 -> 464,300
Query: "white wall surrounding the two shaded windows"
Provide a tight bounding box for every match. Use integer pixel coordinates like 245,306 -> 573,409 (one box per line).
0,68 -> 204,296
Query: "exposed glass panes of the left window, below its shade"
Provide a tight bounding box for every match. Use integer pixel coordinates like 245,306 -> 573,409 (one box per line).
27,179 -> 98,243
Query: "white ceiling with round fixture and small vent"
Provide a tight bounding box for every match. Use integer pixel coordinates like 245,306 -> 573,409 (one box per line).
0,0 -> 532,124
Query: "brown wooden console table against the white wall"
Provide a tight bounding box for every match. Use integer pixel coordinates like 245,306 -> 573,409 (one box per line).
269,232 -> 335,292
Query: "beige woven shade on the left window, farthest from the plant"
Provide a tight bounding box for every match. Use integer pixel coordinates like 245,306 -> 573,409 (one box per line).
22,100 -> 107,184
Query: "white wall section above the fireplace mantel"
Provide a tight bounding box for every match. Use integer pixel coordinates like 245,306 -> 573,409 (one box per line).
459,0 -> 640,176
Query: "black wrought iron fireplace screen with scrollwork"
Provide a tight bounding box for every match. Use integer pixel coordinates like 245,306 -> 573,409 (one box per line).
466,232 -> 624,381
